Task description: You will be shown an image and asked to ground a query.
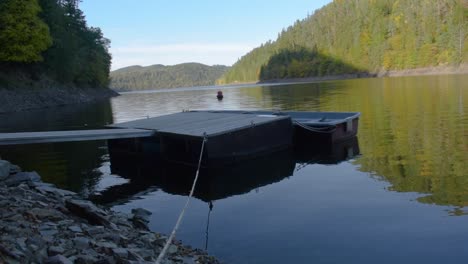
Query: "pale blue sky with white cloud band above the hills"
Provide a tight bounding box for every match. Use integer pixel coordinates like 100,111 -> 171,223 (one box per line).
80,0 -> 331,70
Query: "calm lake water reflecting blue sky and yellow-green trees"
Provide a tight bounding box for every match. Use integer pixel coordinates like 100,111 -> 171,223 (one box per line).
0,75 -> 468,263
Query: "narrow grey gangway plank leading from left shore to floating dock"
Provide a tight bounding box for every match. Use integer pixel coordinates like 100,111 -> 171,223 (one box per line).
0,129 -> 155,145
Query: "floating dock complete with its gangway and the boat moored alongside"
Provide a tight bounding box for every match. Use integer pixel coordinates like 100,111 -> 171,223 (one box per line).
0,111 -> 359,166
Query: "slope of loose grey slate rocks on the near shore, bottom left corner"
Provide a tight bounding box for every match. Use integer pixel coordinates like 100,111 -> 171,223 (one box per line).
0,160 -> 219,264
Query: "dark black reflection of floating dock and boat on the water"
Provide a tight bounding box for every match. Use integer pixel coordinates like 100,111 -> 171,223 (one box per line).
92,138 -> 359,205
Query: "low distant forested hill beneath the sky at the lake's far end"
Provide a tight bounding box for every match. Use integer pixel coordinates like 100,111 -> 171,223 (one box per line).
111,63 -> 229,91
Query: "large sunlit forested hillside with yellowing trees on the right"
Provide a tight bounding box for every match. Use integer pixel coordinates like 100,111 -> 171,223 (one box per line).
217,0 -> 468,84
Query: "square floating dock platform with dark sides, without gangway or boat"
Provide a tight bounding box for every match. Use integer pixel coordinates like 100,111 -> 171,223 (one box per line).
109,112 -> 293,165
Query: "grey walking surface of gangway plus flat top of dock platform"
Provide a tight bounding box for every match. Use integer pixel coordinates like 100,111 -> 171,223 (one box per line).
0,111 -> 289,145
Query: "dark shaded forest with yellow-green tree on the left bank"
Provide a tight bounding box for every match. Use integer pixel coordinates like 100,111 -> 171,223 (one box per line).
0,0 -> 111,89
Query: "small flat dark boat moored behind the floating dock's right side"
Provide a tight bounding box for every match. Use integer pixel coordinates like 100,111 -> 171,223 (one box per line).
192,110 -> 361,145
